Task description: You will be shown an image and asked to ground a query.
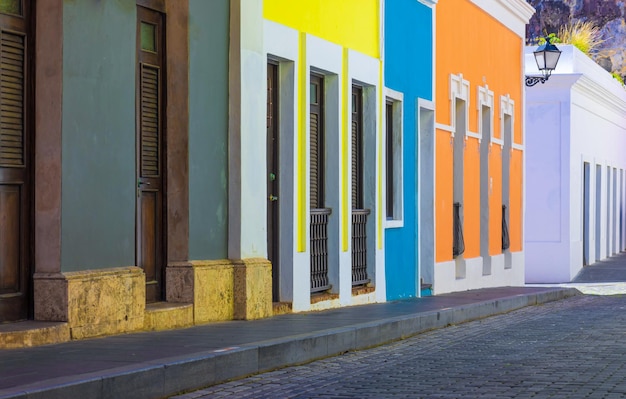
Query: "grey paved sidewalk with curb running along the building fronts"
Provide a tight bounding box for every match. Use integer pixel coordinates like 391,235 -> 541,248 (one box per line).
0,287 -> 579,399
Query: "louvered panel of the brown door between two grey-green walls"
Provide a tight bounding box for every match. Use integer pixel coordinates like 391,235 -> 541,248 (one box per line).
140,63 -> 160,177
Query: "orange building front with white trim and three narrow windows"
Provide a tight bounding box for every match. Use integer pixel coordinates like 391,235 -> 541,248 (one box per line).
434,0 -> 534,293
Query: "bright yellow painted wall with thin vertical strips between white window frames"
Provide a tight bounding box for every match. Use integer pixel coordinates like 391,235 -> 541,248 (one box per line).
263,0 -> 383,252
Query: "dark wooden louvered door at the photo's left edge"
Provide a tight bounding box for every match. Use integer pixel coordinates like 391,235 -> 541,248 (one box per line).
0,0 -> 33,322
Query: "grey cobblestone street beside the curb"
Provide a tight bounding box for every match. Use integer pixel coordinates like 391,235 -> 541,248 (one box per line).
176,295 -> 626,399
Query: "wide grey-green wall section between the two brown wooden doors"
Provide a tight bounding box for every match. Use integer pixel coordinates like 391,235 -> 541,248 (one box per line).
61,0 -> 136,271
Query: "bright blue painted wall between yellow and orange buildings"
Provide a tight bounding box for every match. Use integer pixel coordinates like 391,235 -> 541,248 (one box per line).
384,0 -> 433,300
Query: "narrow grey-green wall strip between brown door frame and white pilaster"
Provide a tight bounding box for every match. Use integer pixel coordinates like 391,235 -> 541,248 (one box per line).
189,0 -> 229,260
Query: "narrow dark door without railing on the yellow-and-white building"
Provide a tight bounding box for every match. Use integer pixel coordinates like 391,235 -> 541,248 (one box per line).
267,62 -> 280,302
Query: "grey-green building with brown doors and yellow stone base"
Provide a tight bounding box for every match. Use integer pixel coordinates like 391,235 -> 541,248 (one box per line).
0,0 -> 272,346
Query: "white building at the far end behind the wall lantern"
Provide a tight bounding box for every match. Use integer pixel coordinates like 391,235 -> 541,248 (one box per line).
525,45 -> 626,283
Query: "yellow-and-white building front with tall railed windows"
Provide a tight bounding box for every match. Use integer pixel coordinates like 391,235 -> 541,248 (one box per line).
262,0 -> 385,311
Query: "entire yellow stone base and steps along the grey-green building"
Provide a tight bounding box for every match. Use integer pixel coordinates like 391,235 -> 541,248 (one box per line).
11,258 -> 270,348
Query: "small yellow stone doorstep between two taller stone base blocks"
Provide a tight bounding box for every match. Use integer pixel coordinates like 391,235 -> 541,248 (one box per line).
143,302 -> 193,331
